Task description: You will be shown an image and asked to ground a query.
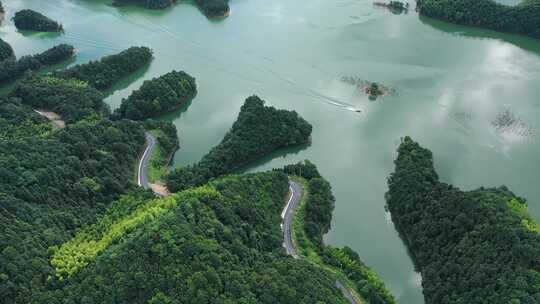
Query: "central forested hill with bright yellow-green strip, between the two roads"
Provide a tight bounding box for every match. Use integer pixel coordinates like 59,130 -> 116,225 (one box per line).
43,172 -> 348,304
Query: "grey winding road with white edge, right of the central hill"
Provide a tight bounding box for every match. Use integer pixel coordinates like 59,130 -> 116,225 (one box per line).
281,180 -> 362,304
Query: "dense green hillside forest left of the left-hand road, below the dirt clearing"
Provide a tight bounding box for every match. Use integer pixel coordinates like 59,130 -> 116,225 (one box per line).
0,105 -> 148,303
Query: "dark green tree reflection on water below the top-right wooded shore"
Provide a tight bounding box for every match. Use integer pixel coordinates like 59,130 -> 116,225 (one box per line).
420,16 -> 540,55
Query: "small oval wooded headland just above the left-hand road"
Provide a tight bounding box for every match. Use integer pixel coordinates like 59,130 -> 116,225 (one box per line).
114,71 -> 197,120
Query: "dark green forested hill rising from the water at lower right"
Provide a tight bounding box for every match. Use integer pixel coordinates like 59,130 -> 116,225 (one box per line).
387,137 -> 540,304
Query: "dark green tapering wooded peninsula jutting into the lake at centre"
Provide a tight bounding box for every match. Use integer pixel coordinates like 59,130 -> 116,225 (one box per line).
167,96 -> 312,192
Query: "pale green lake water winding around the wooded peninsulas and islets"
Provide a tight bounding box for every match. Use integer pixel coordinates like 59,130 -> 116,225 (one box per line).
4,0 -> 540,304
